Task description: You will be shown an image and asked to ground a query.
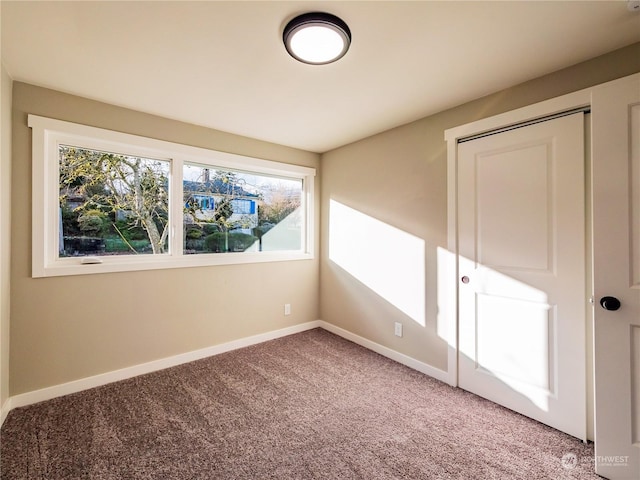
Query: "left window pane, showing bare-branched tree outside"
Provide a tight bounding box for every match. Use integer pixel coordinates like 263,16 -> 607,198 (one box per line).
59,145 -> 170,257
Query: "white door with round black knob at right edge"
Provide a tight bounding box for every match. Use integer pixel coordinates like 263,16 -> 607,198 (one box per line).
592,75 -> 640,480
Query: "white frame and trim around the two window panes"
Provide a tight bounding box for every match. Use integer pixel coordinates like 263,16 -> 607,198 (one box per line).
28,115 -> 316,278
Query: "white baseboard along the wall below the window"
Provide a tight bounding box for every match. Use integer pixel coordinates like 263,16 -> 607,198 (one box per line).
6,320 -> 321,412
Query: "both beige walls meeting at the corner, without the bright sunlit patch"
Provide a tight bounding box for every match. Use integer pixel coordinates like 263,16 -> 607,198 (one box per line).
7,44 -> 640,402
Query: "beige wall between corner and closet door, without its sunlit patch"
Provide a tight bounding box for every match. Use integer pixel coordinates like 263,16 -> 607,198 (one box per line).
320,43 -> 640,370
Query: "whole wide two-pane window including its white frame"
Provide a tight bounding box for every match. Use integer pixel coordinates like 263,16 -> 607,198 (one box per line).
29,115 -> 315,277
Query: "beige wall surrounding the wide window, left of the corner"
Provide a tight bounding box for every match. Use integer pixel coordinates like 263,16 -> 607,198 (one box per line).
10,82 -> 320,396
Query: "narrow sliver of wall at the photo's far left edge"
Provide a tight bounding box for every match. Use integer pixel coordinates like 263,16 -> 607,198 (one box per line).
0,61 -> 12,406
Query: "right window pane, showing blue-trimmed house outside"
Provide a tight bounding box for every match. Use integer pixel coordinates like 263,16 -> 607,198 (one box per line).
183,165 -> 304,254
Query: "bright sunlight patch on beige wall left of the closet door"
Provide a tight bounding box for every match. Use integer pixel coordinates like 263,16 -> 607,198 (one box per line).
329,200 -> 425,326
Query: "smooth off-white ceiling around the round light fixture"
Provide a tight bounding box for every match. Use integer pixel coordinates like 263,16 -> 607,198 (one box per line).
1,0 -> 640,152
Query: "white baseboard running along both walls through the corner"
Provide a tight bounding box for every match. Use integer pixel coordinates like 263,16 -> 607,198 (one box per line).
0,320 -> 449,426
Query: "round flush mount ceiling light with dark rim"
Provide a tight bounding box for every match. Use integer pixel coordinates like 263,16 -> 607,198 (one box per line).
282,12 -> 351,65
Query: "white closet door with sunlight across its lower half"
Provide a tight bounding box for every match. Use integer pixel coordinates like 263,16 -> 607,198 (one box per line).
458,113 -> 586,439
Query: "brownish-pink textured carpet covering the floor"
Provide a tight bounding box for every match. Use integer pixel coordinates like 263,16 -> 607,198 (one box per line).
0,329 -> 600,480
